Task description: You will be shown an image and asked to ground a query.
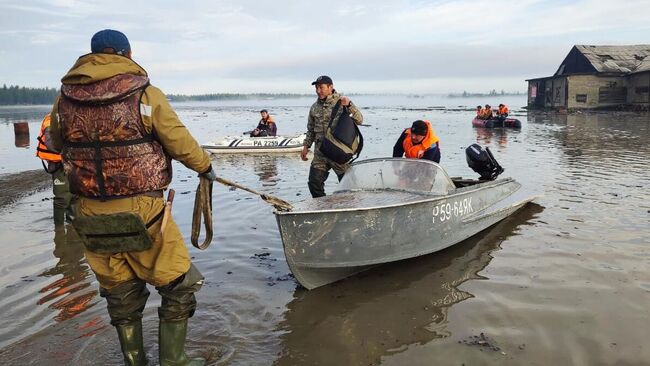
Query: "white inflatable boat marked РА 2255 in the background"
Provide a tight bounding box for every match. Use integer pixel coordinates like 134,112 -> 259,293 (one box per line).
201,134 -> 307,154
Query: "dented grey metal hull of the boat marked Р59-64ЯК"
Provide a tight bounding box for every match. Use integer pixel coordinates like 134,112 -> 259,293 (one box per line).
276,178 -> 529,289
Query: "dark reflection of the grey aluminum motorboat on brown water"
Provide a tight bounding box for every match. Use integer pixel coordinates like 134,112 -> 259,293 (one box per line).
275,204 -> 542,365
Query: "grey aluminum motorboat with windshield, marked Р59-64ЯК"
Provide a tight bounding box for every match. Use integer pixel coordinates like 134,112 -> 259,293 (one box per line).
275,158 -> 535,289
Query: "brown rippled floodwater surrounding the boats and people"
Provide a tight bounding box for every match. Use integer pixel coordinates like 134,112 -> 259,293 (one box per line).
0,96 -> 650,365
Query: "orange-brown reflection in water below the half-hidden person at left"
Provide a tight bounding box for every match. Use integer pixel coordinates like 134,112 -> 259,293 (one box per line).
37,226 -> 98,322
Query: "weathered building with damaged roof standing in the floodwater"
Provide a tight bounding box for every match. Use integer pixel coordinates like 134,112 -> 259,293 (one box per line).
526,45 -> 650,109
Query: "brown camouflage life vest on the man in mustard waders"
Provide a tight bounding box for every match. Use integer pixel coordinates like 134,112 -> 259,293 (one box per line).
58,74 -> 171,199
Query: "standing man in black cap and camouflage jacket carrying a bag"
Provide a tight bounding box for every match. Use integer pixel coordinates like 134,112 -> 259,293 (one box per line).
300,75 -> 363,198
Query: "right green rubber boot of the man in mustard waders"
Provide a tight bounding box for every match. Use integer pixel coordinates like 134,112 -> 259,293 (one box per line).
158,319 -> 205,366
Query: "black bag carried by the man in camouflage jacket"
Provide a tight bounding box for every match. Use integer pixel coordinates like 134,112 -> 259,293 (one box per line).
320,100 -> 363,164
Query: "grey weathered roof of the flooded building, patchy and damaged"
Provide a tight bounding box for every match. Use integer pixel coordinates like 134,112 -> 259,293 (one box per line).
575,44 -> 650,74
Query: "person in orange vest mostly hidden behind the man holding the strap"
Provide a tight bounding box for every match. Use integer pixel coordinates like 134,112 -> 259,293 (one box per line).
36,113 -> 74,227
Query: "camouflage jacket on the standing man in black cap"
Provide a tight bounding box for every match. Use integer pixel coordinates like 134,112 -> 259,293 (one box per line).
303,92 -> 363,148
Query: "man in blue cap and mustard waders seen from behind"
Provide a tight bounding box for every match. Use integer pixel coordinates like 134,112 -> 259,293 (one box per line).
51,29 -> 215,365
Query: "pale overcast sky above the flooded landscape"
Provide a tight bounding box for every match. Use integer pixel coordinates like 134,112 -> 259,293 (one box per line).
0,0 -> 650,94
